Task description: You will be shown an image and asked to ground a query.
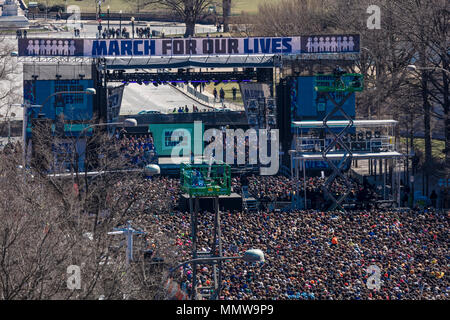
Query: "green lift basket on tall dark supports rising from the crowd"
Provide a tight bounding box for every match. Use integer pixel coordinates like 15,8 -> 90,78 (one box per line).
180,163 -> 231,300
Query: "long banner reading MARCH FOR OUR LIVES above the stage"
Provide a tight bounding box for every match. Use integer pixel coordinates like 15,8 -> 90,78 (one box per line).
19,34 -> 360,57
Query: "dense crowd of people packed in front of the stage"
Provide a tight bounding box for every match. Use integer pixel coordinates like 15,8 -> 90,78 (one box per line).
118,177 -> 450,300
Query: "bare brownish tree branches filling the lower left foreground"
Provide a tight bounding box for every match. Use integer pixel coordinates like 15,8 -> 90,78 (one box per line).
0,122 -> 183,299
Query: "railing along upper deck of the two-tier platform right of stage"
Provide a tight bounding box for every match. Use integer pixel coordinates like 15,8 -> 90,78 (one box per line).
296,136 -> 395,153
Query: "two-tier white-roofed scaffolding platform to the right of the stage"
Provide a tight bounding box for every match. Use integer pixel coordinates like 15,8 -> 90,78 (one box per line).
289,119 -> 404,210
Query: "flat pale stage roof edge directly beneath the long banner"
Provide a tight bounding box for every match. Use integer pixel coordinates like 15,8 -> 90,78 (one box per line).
103,55 -> 279,69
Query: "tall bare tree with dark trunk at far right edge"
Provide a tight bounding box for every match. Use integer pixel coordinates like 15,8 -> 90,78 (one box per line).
384,0 -> 449,195
